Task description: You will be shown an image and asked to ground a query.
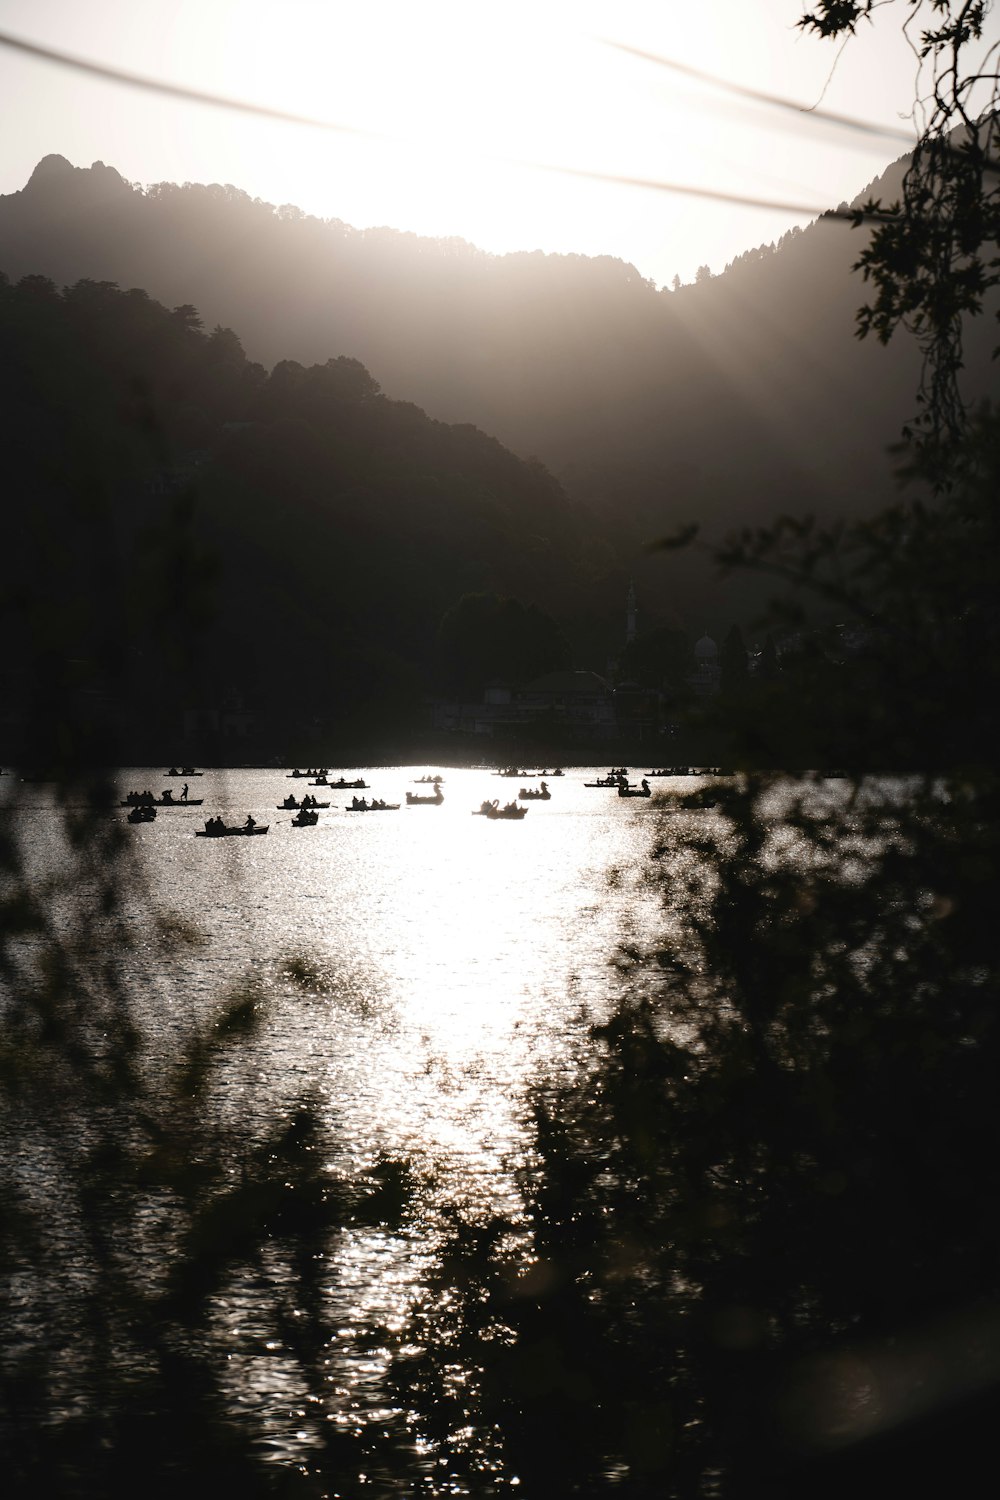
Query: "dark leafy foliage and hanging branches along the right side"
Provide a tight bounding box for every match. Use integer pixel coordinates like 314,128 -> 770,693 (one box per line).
386,0 -> 1000,1500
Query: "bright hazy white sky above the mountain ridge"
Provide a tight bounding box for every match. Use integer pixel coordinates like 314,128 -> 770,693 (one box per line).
0,0 -> 999,284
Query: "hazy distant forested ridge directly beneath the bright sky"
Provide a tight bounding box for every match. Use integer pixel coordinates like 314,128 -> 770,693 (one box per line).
0,146 -> 990,630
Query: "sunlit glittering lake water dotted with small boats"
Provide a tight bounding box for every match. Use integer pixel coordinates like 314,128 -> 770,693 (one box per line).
7,767 -> 699,1430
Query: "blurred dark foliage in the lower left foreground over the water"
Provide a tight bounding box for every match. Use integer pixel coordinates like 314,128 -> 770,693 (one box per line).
0,780 -> 422,1500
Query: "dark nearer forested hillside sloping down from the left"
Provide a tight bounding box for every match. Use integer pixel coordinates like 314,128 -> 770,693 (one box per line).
0,276 -> 624,759
